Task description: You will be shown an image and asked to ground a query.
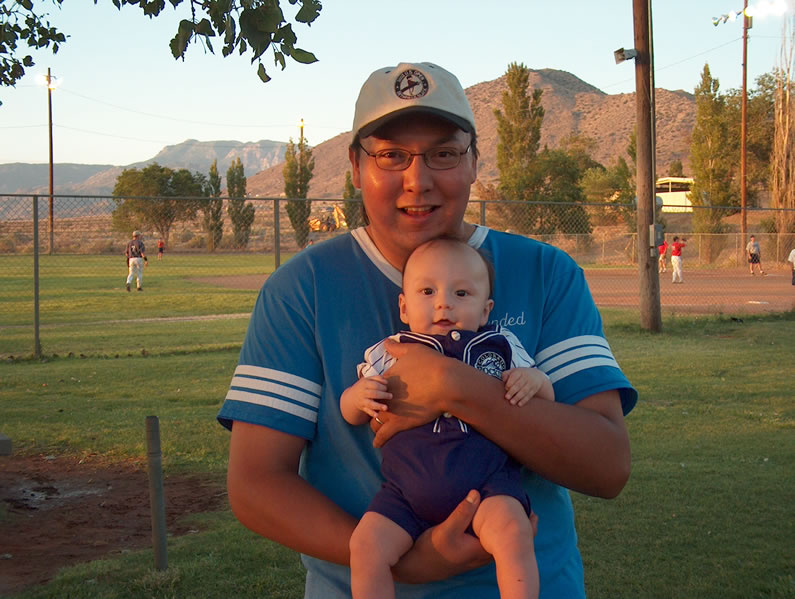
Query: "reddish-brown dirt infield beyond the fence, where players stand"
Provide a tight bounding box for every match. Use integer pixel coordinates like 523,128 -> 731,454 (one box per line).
198,268 -> 795,315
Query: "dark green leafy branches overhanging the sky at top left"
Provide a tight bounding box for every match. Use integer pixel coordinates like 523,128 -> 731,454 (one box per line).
0,0 -> 323,100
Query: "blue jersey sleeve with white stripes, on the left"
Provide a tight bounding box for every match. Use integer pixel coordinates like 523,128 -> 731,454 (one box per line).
218,263 -> 323,439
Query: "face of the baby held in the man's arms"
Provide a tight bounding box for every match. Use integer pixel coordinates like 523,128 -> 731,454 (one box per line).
400,242 -> 494,335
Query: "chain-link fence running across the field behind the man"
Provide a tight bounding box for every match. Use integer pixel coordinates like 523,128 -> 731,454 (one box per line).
0,195 -> 795,354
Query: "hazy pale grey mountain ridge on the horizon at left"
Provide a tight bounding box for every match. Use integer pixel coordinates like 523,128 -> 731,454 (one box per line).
0,139 -> 286,195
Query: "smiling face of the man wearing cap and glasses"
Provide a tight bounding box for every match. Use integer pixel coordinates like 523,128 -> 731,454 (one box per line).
350,114 -> 477,268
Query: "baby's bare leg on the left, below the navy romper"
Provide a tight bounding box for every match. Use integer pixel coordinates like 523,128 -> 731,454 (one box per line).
350,512 -> 413,599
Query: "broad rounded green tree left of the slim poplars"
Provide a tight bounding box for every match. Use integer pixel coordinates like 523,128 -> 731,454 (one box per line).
113,162 -> 207,245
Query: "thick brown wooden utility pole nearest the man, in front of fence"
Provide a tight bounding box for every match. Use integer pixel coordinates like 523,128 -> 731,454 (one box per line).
633,0 -> 662,333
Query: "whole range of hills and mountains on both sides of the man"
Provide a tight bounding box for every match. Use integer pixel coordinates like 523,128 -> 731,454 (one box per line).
0,69 -> 695,198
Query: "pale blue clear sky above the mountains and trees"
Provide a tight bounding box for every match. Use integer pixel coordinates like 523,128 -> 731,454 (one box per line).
0,0 -> 795,165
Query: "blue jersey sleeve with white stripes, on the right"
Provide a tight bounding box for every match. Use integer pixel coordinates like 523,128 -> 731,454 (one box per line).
535,255 -> 638,414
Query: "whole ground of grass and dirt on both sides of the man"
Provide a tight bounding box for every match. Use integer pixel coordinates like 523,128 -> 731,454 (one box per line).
0,254 -> 795,599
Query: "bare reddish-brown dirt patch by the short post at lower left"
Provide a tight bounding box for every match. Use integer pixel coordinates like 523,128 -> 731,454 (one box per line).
0,456 -> 227,596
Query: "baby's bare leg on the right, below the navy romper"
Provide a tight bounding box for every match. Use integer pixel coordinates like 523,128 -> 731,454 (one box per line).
472,495 -> 538,599
